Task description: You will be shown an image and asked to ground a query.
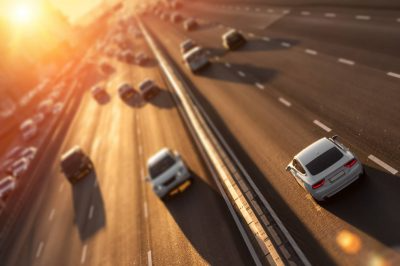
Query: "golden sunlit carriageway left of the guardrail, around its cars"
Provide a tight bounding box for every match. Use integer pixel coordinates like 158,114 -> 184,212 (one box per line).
0,20 -> 253,265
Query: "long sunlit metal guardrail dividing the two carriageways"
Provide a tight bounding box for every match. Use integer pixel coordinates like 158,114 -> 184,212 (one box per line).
138,18 -> 310,265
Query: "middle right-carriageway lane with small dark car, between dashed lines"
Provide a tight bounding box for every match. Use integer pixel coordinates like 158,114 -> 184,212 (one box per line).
150,15 -> 400,168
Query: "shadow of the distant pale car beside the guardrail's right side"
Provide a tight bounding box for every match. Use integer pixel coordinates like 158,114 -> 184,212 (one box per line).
197,62 -> 278,85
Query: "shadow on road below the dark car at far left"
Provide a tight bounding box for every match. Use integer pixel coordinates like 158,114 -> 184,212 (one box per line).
71,170 -> 106,241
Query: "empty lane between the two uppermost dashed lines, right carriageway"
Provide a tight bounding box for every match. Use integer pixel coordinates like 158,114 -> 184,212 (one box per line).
184,3 -> 400,72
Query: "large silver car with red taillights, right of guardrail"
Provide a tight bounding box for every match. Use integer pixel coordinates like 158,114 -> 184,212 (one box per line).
286,136 -> 364,201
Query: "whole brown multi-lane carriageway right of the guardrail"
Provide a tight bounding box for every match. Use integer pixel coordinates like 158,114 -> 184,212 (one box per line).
143,3 -> 400,265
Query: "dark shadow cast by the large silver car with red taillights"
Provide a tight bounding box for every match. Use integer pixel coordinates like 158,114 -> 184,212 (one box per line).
321,165 -> 400,247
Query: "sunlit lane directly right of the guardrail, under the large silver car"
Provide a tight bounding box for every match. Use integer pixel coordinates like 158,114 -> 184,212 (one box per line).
144,16 -> 398,263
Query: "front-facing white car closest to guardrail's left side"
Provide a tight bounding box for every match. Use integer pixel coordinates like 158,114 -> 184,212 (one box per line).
146,148 -> 192,199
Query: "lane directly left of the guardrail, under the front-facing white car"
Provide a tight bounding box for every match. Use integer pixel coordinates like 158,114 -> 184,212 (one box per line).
128,39 -> 252,265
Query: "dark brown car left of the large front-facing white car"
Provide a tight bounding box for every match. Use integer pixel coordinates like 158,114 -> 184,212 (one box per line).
61,146 -> 94,184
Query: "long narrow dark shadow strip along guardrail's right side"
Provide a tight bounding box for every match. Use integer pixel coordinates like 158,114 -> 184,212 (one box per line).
173,68 -> 335,265
